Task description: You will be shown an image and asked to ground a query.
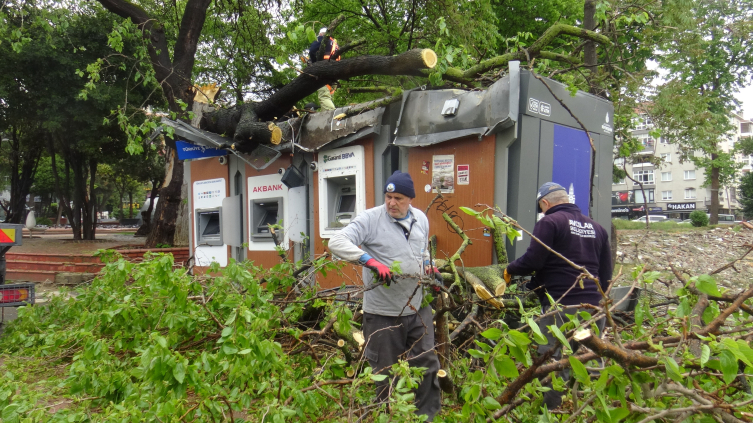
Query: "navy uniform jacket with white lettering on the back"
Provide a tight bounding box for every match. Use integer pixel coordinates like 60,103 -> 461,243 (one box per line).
507,203 -> 612,305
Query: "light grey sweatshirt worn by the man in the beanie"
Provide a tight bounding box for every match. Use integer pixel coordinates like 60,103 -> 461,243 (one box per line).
328,204 -> 429,316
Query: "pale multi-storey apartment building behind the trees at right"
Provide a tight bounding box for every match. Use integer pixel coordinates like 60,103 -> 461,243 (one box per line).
612,114 -> 753,219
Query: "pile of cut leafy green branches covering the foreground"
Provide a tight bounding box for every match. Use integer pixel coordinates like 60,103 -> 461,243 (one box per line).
0,210 -> 753,422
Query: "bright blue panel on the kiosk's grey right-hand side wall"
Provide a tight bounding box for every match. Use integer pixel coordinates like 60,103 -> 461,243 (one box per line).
552,124 -> 591,215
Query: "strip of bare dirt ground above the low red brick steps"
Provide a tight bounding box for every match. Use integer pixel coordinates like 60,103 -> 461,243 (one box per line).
9,233 -> 146,254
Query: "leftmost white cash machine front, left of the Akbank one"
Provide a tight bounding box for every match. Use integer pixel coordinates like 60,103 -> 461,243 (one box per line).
193,178 -> 227,266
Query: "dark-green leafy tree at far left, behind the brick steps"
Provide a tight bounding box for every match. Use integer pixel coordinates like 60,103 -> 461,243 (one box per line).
0,4 -> 160,239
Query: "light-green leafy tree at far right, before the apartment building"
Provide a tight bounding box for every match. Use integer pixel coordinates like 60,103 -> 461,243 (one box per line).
652,0 -> 753,224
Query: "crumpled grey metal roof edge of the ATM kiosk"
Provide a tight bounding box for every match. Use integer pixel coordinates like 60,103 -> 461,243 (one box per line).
162,62 -> 613,156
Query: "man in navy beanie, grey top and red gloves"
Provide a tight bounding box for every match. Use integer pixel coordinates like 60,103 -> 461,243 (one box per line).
328,171 -> 441,421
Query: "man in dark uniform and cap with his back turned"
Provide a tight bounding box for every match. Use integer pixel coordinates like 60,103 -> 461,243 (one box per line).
504,182 -> 612,410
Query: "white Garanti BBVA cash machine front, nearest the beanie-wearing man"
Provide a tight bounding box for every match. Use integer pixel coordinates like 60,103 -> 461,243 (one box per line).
318,145 -> 366,238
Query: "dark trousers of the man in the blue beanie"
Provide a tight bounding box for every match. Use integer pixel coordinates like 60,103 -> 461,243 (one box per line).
363,307 -> 442,421
